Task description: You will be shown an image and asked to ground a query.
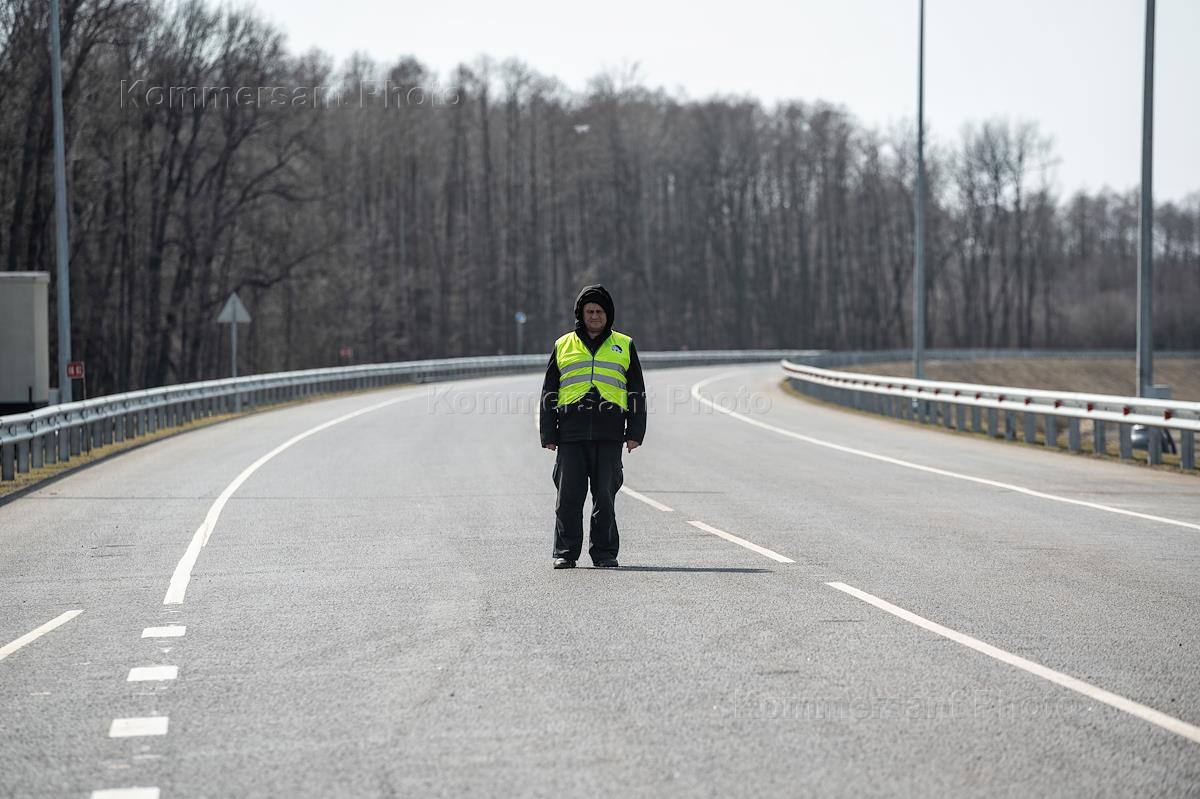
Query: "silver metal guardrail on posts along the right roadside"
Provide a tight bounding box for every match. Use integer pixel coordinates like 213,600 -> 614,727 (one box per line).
780,353 -> 1200,470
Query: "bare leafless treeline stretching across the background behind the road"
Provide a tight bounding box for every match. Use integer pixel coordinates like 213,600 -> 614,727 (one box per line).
0,0 -> 1200,391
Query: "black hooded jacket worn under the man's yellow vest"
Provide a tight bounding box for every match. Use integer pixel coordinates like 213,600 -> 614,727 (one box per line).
540,284 -> 646,446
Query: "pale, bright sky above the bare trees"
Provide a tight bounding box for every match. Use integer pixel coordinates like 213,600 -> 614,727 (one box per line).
248,0 -> 1200,202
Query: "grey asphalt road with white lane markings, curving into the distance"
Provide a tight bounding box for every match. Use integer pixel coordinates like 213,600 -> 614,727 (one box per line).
0,366 -> 1200,798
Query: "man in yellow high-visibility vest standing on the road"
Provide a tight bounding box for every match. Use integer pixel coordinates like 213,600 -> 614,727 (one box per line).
540,284 -> 646,569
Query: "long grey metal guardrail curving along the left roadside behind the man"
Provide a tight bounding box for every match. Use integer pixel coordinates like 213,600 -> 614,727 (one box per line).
0,349 -> 816,480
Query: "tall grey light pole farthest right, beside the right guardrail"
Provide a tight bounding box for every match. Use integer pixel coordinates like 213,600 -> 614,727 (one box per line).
1138,0 -> 1154,397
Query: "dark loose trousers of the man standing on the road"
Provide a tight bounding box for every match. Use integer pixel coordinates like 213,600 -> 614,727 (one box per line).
553,441 -> 625,563
